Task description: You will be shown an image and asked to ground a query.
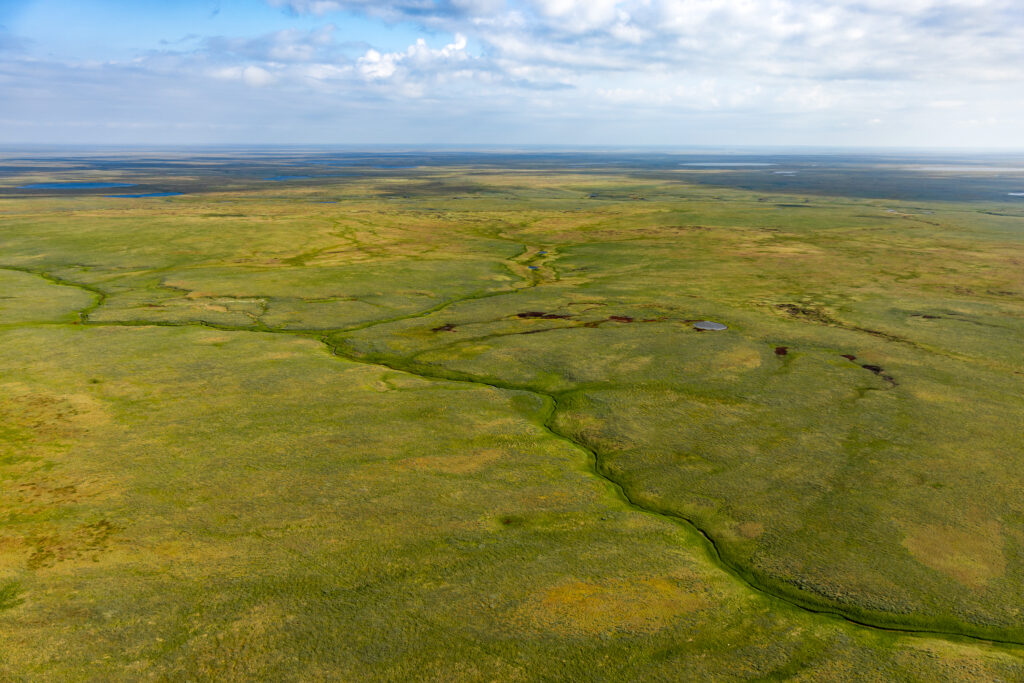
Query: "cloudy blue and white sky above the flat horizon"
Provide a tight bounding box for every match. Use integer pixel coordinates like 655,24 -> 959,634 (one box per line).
0,0 -> 1024,151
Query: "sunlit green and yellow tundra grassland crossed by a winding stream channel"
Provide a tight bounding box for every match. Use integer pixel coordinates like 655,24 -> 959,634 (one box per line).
0,158 -> 1024,681
